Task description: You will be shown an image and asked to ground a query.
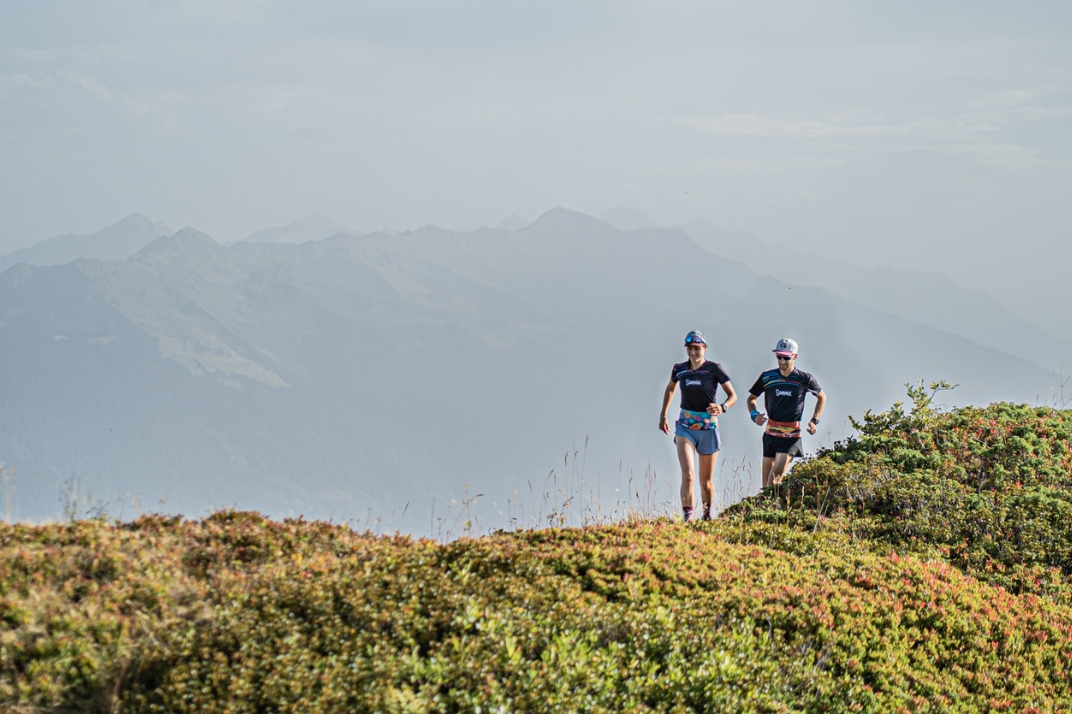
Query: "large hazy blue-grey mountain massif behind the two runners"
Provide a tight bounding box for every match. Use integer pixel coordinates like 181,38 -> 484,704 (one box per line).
0,209 -> 1052,531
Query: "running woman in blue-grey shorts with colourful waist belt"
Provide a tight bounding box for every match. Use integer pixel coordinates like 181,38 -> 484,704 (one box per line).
659,330 -> 736,521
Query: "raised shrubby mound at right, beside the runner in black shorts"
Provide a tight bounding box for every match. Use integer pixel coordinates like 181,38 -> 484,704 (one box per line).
727,392 -> 1072,600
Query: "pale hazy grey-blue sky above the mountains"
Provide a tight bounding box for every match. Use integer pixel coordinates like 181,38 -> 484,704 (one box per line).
0,0 -> 1072,310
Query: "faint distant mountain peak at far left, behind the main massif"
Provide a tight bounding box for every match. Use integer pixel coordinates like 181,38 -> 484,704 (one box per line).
0,213 -> 172,271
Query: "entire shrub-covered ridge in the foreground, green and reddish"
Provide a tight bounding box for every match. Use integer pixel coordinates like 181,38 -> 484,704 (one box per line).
6,398 -> 1072,712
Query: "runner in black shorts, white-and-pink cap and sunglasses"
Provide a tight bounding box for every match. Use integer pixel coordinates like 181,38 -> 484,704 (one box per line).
747,338 -> 827,488
